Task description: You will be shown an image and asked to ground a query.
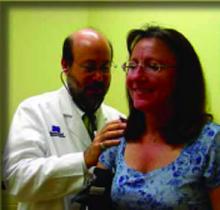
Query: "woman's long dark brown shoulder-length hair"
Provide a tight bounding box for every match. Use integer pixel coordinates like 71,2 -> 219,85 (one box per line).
125,26 -> 212,144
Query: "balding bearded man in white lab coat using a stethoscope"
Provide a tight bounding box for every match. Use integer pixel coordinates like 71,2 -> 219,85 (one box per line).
4,29 -> 125,210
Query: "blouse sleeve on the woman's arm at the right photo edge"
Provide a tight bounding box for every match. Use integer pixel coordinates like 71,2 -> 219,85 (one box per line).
204,129 -> 220,188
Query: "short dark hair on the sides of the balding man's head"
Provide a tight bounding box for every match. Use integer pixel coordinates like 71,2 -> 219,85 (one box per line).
62,32 -> 113,67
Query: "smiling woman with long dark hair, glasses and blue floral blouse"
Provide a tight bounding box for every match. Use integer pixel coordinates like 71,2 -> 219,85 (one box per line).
98,26 -> 220,210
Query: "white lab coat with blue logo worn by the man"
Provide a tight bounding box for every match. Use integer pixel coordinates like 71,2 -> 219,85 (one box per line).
4,87 -> 123,210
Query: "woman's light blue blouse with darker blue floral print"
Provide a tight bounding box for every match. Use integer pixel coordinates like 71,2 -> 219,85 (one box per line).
99,123 -> 220,210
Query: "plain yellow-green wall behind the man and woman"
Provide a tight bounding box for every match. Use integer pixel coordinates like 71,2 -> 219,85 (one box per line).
8,3 -> 220,127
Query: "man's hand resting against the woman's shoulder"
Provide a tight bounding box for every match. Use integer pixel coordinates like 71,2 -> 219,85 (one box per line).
84,120 -> 126,168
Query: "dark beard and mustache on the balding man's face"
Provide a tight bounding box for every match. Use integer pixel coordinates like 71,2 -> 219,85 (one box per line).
67,77 -> 108,113
